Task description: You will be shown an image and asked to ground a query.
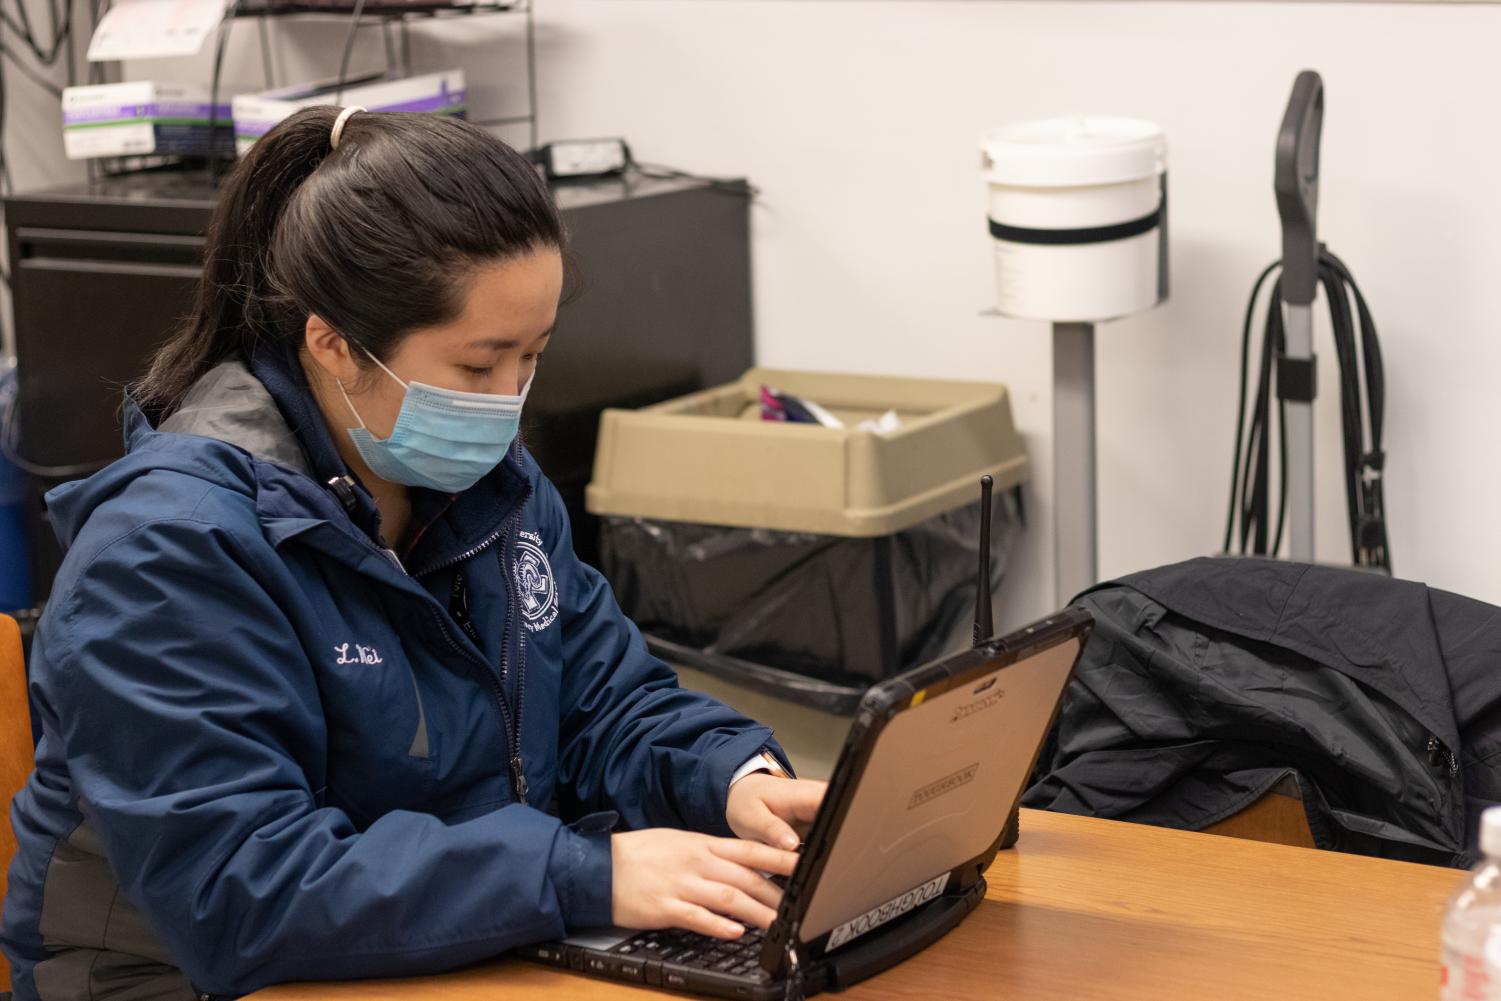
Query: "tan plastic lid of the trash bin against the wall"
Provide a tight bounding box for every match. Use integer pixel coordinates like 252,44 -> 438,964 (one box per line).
585,369 -> 1027,537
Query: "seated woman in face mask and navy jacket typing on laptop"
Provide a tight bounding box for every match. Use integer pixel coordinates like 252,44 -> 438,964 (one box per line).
0,108 -> 823,1001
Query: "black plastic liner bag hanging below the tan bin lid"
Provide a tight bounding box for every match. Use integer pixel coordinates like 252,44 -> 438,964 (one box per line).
600,494 -> 1021,711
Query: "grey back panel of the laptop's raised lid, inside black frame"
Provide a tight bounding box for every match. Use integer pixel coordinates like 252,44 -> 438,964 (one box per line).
799,636 -> 1079,951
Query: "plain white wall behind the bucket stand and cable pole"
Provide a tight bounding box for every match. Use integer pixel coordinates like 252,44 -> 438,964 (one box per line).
55,0 -> 1501,621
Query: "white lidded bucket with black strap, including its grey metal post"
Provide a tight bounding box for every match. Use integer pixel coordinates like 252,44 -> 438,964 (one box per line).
982,117 -> 1168,606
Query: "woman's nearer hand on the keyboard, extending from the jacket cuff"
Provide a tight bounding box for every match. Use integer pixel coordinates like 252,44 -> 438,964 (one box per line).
609,828 -> 797,938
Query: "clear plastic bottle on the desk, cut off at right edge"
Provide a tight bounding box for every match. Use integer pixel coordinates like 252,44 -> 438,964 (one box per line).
1439,806 -> 1501,1001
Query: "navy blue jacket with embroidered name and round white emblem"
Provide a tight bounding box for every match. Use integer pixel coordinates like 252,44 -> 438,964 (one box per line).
0,363 -> 781,1001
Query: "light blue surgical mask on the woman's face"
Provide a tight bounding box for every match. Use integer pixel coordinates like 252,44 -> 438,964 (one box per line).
339,348 -> 531,494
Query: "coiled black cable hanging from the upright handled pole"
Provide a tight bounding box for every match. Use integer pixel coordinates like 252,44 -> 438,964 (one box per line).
1223,245 -> 1391,573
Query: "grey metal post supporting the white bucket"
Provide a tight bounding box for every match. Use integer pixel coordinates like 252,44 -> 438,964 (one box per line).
1052,323 -> 1099,608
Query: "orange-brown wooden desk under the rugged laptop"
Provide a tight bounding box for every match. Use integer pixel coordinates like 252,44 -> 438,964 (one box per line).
254,810 -> 1463,1001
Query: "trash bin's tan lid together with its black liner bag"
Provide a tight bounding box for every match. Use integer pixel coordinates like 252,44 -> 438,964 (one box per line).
587,369 -> 1027,713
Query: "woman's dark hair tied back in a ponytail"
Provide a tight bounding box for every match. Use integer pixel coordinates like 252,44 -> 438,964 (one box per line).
132,107 -> 563,417
